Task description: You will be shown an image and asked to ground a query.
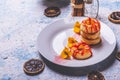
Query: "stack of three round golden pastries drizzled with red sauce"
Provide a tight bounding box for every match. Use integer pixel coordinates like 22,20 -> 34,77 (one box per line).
80,18 -> 101,45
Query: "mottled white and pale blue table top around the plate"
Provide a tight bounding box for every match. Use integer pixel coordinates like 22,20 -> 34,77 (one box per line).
0,0 -> 120,80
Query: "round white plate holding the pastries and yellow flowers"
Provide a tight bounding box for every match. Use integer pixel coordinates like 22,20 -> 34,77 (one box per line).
37,18 -> 116,67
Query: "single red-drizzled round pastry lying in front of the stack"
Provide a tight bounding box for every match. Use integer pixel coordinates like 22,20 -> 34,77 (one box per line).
71,42 -> 92,60
